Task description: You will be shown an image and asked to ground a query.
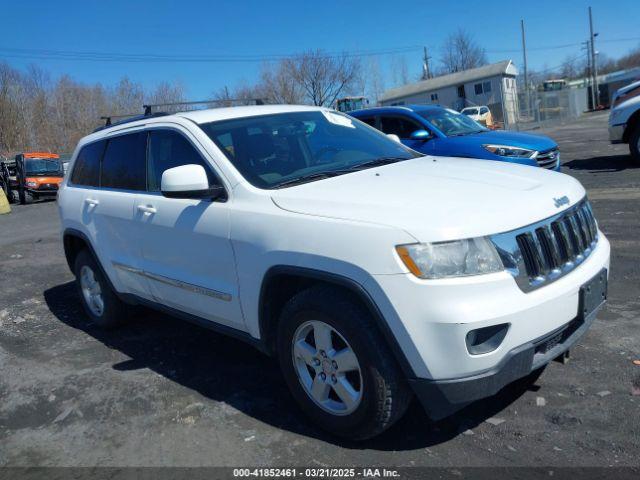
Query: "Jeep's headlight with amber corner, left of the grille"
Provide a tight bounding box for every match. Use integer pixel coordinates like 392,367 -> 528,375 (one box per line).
396,237 -> 504,279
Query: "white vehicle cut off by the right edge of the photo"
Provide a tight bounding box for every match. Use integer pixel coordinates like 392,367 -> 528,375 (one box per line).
609,82 -> 640,162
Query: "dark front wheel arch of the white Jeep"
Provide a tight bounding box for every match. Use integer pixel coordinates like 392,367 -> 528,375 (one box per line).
258,265 -> 415,378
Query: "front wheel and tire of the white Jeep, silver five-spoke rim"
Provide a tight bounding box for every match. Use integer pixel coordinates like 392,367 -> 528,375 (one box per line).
277,285 -> 412,440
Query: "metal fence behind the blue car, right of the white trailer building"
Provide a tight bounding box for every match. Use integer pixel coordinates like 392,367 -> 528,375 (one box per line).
505,87 -> 589,130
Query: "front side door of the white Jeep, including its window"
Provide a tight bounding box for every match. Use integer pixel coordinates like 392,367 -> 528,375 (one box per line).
134,127 -> 246,330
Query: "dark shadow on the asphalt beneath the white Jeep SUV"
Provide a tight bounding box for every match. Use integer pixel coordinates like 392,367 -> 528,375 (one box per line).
44,282 -> 537,451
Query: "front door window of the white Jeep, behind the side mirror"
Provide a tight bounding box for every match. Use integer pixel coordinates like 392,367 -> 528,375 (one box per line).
147,130 -> 218,192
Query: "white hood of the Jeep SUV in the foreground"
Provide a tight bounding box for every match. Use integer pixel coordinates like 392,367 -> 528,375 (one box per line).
272,157 -> 585,242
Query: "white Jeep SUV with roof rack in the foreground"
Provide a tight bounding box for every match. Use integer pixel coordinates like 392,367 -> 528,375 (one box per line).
58,106 -> 609,439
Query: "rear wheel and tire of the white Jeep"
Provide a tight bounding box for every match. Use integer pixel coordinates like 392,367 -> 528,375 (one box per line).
73,249 -> 129,329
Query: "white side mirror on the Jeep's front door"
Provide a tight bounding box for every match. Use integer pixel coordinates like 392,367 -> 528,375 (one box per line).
160,165 -> 225,200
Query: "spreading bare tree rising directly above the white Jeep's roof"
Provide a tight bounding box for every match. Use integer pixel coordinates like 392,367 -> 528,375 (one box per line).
282,50 -> 360,106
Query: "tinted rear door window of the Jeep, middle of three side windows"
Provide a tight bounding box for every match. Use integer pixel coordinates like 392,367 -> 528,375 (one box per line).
100,132 -> 147,190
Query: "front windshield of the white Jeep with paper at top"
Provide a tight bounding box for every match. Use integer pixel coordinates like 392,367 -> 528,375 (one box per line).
200,110 -> 420,188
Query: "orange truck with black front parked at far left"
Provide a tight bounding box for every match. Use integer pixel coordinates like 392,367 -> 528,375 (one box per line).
7,152 -> 64,204
